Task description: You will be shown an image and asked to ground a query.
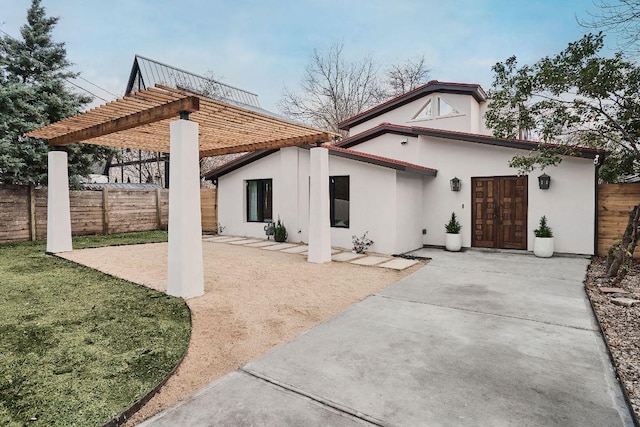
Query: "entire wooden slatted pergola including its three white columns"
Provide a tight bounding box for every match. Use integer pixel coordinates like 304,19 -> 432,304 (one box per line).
27,85 -> 337,298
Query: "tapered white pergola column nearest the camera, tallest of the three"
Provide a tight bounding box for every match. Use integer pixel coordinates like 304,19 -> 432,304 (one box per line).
167,119 -> 204,298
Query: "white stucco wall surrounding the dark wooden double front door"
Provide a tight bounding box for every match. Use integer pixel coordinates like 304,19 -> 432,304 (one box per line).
420,137 -> 595,254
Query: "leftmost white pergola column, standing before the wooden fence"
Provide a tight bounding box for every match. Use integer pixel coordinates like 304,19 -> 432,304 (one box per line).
47,151 -> 73,253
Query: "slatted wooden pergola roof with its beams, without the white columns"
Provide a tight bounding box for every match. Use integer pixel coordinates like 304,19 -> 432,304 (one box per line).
27,85 -> 336,157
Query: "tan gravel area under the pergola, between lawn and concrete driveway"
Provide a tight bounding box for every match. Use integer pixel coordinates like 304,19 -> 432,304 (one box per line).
57,242 -> 424,425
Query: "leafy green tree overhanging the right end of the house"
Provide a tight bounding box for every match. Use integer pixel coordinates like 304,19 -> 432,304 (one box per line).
486,34 -> 640,277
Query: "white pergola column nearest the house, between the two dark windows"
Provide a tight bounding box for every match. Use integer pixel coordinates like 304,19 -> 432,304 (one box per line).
307,147 -> 331,264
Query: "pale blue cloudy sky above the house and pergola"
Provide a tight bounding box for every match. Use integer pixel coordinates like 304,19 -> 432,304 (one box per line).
0,0 -> 614,112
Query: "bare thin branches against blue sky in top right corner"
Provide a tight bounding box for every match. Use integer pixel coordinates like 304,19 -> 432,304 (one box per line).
580,0 -> 640,55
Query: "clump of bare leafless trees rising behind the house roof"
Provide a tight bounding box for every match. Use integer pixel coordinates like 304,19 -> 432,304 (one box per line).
278,42 -> 429,133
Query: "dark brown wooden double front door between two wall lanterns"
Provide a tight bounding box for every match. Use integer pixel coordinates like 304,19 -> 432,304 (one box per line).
471,176 -> 527,249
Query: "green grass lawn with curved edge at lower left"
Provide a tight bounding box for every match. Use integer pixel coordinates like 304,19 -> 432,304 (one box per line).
0,232 -> 191,426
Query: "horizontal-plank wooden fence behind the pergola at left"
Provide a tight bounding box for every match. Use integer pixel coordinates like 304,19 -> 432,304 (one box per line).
0,185 -> 218,243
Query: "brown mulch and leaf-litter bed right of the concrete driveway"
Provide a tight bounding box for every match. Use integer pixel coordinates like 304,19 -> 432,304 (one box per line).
585,258 -> 640,417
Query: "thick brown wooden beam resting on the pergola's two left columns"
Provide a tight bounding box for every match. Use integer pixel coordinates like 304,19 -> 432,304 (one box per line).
49,96 -> 200,146
